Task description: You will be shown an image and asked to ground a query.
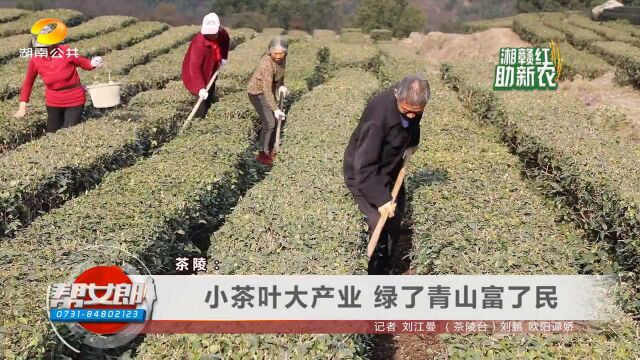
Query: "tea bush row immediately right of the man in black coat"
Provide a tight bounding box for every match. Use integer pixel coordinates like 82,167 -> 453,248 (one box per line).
376,47 -> 639,359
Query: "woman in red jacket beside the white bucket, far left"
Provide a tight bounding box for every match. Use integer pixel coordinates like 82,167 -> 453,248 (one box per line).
15,25 -> 102,132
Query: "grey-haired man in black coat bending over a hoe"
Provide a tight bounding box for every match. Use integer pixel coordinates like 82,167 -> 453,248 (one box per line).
343,75 -> 431,275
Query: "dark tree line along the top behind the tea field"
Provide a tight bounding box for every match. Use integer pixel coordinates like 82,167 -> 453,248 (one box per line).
7,0 -> 640,37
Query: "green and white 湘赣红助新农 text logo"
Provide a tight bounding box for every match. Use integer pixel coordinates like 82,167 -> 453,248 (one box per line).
493,41 -> 563,90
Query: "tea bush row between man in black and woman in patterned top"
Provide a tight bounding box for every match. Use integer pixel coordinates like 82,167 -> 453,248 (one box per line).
138,69 -> 378,359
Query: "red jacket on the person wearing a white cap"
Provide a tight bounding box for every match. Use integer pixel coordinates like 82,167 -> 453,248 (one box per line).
182,27 -> 229,95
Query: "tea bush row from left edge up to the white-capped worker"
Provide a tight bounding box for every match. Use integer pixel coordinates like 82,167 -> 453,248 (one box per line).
0,33 -> 258,235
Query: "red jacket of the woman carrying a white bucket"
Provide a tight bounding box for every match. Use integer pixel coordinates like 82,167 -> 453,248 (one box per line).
20,45 -> 94,107
